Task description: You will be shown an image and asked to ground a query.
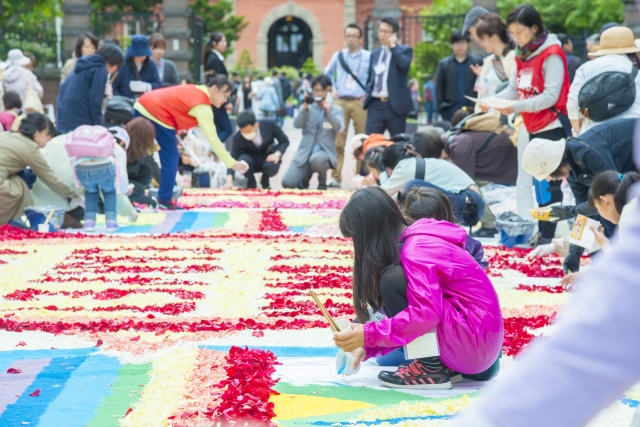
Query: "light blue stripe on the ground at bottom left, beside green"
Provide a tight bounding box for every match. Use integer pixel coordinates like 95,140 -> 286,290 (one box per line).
38,354 -> 120,427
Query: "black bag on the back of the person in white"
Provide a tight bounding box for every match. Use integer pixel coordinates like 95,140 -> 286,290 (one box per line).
578,67 -> 638,122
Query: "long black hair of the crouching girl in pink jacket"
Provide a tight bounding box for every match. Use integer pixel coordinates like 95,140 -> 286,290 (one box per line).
340,187 -> 406,323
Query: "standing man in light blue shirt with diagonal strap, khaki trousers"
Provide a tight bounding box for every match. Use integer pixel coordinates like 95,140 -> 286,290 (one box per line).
324,24 -> 371,187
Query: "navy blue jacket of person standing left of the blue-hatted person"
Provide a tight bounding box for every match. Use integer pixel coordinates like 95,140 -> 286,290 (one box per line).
56,55 -> 107,133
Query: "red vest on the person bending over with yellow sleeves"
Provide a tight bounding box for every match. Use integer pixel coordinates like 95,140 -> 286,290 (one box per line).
138,85 -> 211,130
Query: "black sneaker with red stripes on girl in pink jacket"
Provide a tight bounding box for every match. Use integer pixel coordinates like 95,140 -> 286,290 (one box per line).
378,359 -> 451,390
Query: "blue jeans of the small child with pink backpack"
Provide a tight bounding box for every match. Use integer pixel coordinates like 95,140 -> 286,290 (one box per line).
76,164 -> 116,221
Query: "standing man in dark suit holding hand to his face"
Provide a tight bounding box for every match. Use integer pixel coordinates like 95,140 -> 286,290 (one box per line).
364,18 -> 413,136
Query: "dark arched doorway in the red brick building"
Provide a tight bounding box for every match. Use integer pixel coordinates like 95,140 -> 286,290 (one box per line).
268,16 -> 313,68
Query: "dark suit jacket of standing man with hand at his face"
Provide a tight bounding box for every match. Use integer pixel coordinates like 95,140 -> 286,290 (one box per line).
364,44 -> 413,116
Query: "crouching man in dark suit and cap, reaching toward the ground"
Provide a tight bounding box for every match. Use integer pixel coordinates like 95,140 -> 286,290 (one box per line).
225,110 -> 289,189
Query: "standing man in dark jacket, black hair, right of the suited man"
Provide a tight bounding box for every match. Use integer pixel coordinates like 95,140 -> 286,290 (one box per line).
436,30 -> 482,121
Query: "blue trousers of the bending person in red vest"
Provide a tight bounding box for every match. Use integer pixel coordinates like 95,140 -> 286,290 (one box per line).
133,110 -> 180,202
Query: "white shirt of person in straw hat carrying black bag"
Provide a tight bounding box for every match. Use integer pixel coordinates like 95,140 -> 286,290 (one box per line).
567,55 -> 640,134
